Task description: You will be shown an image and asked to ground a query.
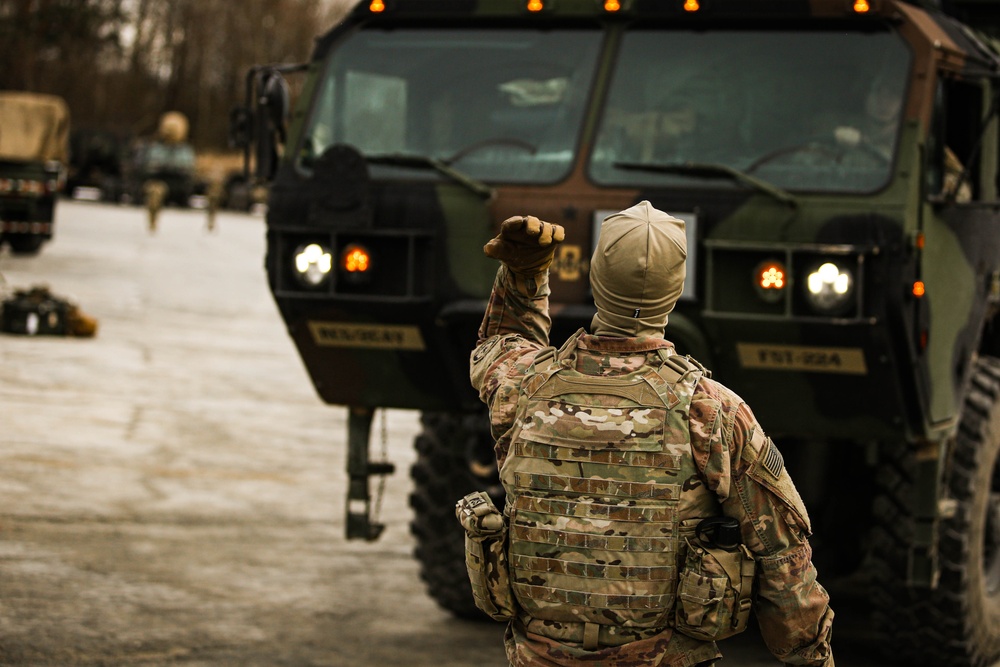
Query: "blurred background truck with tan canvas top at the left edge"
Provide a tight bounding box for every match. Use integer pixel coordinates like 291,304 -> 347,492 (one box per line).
0,91 -> 69,254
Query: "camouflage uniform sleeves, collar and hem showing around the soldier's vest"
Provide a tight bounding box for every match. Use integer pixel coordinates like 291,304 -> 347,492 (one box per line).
471,266 -> 833,667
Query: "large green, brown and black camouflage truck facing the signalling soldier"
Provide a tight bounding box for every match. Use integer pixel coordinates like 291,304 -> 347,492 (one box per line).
234,0 -> 1000,667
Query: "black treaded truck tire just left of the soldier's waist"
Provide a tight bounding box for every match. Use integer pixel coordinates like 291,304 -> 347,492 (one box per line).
410,413 -> 502,620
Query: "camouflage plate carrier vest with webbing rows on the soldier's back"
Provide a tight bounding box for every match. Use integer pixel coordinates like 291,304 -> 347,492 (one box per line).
500,336 -> 752,648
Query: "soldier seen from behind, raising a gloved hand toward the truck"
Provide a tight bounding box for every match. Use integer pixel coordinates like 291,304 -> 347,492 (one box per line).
464,201 -> 834,667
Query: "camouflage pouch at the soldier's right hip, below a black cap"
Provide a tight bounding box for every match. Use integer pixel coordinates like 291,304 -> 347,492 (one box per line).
675,538 -> 754,641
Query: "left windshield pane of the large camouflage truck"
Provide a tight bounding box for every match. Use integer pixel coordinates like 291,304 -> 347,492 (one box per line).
300,28 -> 602,182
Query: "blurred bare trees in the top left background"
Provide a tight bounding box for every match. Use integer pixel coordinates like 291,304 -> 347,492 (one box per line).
0,0 -> 351,148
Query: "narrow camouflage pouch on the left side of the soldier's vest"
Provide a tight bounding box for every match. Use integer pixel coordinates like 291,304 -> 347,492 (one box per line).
455,491 -> 516,621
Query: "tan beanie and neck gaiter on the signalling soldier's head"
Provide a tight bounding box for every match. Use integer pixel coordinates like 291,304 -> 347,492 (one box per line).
590,201 -> 687,337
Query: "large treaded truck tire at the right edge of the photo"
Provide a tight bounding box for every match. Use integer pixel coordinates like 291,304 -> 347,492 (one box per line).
872,357 -> 1000,667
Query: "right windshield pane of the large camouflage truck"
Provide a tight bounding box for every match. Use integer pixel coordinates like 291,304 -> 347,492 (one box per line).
590,30 -> 910,192
